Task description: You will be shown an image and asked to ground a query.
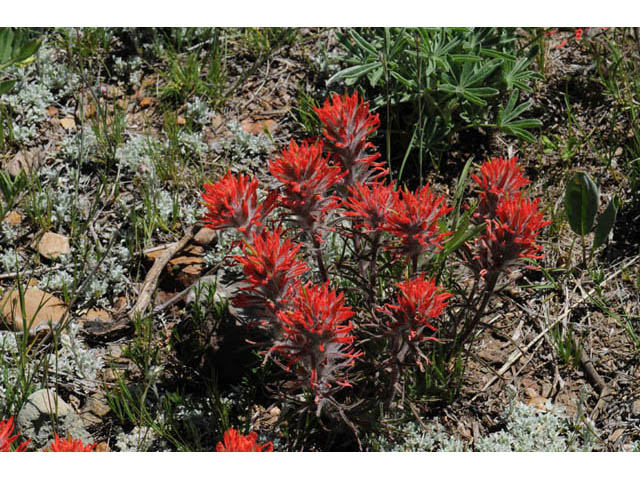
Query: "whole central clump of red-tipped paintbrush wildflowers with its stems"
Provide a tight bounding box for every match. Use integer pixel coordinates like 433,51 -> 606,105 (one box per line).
202,93 -> 550,442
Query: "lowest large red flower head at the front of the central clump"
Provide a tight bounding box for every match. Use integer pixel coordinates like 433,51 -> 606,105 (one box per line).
272,282 -> 359,401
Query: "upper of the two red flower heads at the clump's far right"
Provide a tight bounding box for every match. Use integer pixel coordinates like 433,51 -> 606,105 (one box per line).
471,157 -> 529,218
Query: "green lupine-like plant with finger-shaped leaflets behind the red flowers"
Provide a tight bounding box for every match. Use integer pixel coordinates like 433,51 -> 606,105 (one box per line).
329,28 -> 542,178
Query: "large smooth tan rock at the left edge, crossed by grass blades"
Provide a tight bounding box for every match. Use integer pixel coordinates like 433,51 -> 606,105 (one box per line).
0,288 -> 68,334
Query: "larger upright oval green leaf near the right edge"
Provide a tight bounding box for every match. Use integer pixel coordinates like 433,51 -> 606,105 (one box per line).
564,172 -> 599,236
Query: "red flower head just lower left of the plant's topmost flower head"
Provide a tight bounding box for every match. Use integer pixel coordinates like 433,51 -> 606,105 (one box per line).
269,140 -> 345,234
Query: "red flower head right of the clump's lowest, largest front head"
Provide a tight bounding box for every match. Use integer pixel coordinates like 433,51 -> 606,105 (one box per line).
380,273 -> 453,341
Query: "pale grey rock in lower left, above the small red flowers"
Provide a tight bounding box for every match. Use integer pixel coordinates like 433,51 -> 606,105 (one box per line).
16,389 -> 92,448
